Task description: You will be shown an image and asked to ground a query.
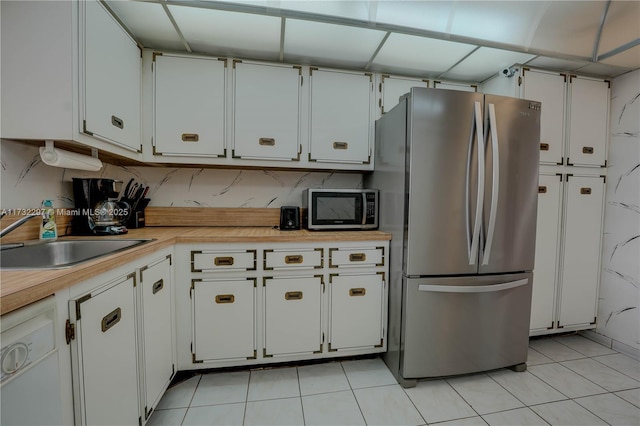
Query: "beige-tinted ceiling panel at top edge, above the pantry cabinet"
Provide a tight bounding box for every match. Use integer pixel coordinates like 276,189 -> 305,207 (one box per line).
531,1 -> 606,58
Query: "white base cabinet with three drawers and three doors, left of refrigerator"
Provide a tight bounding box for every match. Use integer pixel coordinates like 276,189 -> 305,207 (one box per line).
176,241 -> 389,370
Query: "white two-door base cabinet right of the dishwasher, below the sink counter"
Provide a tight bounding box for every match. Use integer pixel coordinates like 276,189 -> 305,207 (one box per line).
66,254 -> 175,425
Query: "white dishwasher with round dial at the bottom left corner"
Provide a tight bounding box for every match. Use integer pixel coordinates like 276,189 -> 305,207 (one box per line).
0,296 -> 62,425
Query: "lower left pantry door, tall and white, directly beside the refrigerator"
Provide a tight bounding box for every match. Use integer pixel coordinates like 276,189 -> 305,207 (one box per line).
530,175 -> 562,330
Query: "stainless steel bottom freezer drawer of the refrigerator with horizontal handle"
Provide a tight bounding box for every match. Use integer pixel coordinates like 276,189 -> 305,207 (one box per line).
400,273 -> 533,379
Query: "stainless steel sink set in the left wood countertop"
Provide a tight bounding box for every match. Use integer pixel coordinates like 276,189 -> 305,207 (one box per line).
0,239 -> 153,270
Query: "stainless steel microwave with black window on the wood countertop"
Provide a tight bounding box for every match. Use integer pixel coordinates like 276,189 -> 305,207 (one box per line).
302,188 -> 378,230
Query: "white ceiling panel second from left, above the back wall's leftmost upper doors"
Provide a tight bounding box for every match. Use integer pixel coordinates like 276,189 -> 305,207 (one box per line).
169,6 -> 281,60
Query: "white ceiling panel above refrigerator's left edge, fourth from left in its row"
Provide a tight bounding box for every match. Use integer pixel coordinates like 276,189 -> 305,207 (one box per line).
371,34 -> 476,76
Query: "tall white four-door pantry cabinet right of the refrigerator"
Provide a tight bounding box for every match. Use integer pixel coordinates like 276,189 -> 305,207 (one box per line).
483,67 -> 610,335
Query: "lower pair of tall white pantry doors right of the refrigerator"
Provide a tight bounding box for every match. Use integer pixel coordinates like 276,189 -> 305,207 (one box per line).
530,174 -> 605,335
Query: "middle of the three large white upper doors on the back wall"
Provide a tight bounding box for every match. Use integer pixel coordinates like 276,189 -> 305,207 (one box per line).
233,61 -> 301,161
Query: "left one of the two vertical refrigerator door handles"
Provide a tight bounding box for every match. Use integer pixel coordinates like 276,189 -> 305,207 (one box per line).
466,101 -> 484,265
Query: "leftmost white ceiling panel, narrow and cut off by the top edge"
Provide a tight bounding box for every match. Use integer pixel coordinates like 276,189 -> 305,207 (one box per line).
102,1 -> 184,50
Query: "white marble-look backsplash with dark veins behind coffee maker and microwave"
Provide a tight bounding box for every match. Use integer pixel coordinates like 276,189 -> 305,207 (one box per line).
0,140 -> 362,209
